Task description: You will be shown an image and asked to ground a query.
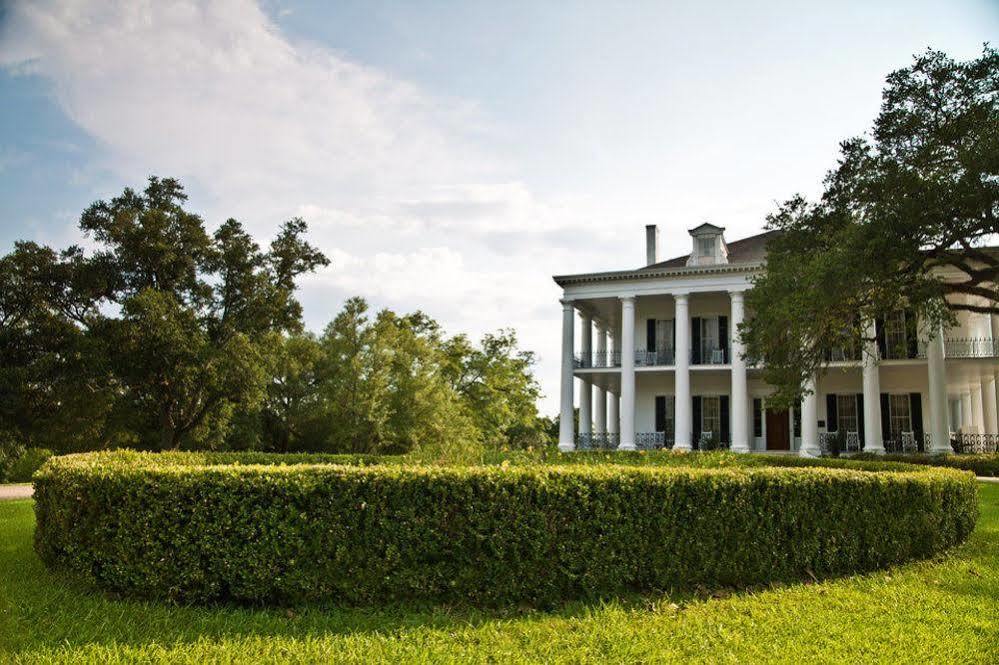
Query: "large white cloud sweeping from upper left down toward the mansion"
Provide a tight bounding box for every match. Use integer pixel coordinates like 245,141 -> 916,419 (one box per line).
0,0 -> 609,411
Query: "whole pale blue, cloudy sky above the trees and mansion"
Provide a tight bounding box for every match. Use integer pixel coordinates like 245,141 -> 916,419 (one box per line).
0,0 -> 999,414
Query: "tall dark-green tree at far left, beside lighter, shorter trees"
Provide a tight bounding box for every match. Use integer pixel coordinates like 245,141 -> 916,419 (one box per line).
0,177 -> 329,448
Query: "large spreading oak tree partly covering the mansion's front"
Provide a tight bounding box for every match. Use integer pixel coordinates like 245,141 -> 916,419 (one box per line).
740,45 -> 999,403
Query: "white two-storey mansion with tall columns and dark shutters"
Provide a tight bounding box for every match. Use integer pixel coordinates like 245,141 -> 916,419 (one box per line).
554,224 -> 999,455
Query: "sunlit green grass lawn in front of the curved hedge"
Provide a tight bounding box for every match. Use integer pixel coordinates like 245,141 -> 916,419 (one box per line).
0,483 -> 999,663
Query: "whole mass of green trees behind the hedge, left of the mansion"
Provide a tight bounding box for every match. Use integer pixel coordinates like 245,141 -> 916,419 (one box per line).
0,177 -> 547,452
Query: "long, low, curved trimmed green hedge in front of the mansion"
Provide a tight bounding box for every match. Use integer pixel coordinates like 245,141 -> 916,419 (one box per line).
35,453 -> 978,605
